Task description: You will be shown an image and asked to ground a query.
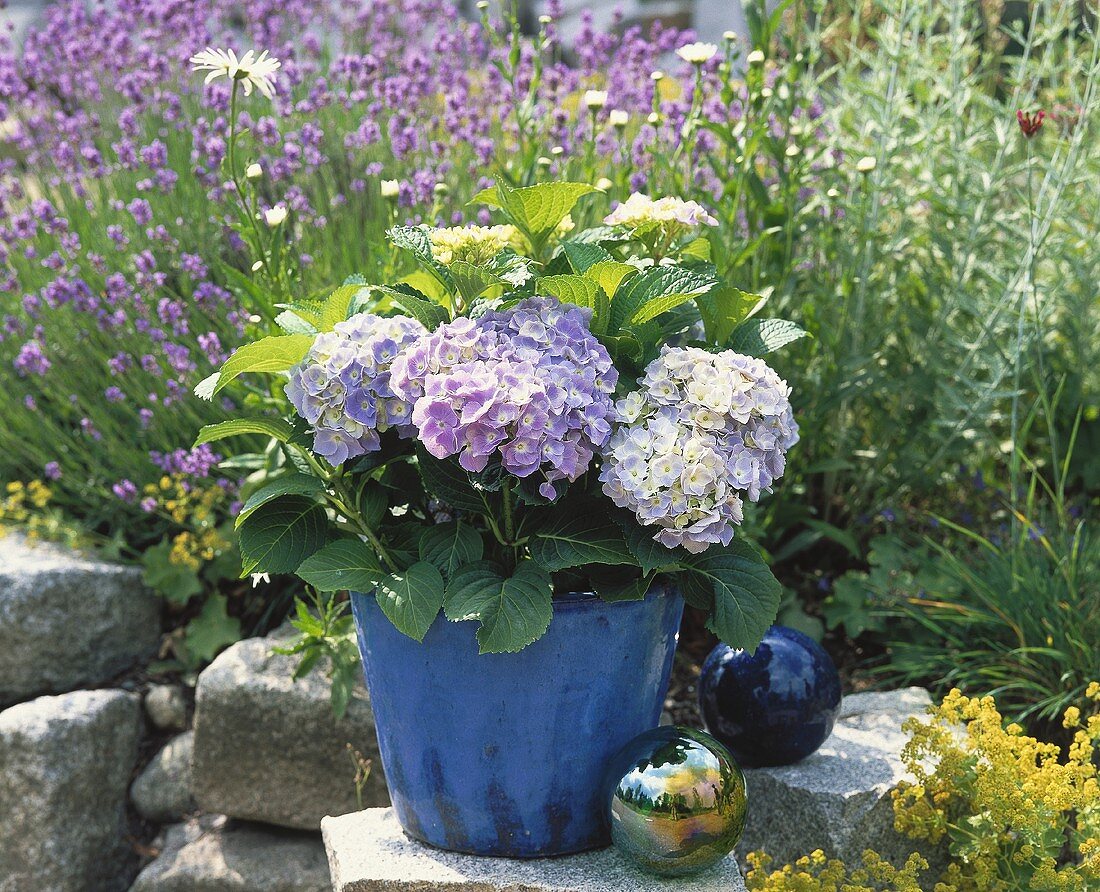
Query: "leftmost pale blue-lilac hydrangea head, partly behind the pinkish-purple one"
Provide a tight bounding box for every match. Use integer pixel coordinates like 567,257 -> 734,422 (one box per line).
286,312 -> 427,465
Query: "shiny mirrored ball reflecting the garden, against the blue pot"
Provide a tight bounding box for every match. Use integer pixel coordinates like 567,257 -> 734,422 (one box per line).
605,727 -> 746,877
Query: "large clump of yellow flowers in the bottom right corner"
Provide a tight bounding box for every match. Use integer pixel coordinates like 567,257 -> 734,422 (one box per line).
893,684 -> 1100,892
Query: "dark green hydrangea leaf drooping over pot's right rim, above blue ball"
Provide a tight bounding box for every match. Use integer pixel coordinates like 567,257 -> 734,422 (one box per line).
681,539 -> 782,651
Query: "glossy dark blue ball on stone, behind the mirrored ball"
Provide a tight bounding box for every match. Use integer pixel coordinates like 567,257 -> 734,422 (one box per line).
699,626 -> 840,767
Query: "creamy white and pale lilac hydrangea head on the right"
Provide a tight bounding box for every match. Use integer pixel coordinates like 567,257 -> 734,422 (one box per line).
600,346 -> 799,553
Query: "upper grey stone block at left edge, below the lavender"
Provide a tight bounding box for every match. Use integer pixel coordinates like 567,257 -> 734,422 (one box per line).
0,535 -> 161,707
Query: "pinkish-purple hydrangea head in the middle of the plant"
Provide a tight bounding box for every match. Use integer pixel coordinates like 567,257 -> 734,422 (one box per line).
392,297 -> 618,498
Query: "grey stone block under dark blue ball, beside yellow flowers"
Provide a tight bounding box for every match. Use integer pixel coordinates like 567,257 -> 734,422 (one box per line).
737,689 -> 936,865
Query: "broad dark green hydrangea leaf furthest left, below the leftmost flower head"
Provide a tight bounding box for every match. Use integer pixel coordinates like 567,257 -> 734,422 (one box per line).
240,495 -> 329,576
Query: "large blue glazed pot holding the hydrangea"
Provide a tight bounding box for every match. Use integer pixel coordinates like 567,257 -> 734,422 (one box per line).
352,586 -> 683,858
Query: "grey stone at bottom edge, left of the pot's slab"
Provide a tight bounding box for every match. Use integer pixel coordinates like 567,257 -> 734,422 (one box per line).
130,816 -> 330,892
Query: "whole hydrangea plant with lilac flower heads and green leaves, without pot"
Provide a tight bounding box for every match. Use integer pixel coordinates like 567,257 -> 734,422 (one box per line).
198,181 -> 805,652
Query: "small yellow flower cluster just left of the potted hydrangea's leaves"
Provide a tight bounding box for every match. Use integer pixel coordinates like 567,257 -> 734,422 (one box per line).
142,474 -> 231,570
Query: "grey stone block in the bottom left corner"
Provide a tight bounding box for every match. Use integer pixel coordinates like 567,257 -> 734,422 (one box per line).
0,691 -> 141,892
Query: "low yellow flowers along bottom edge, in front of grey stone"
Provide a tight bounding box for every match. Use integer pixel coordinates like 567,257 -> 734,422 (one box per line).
745,849 -> 942,892
